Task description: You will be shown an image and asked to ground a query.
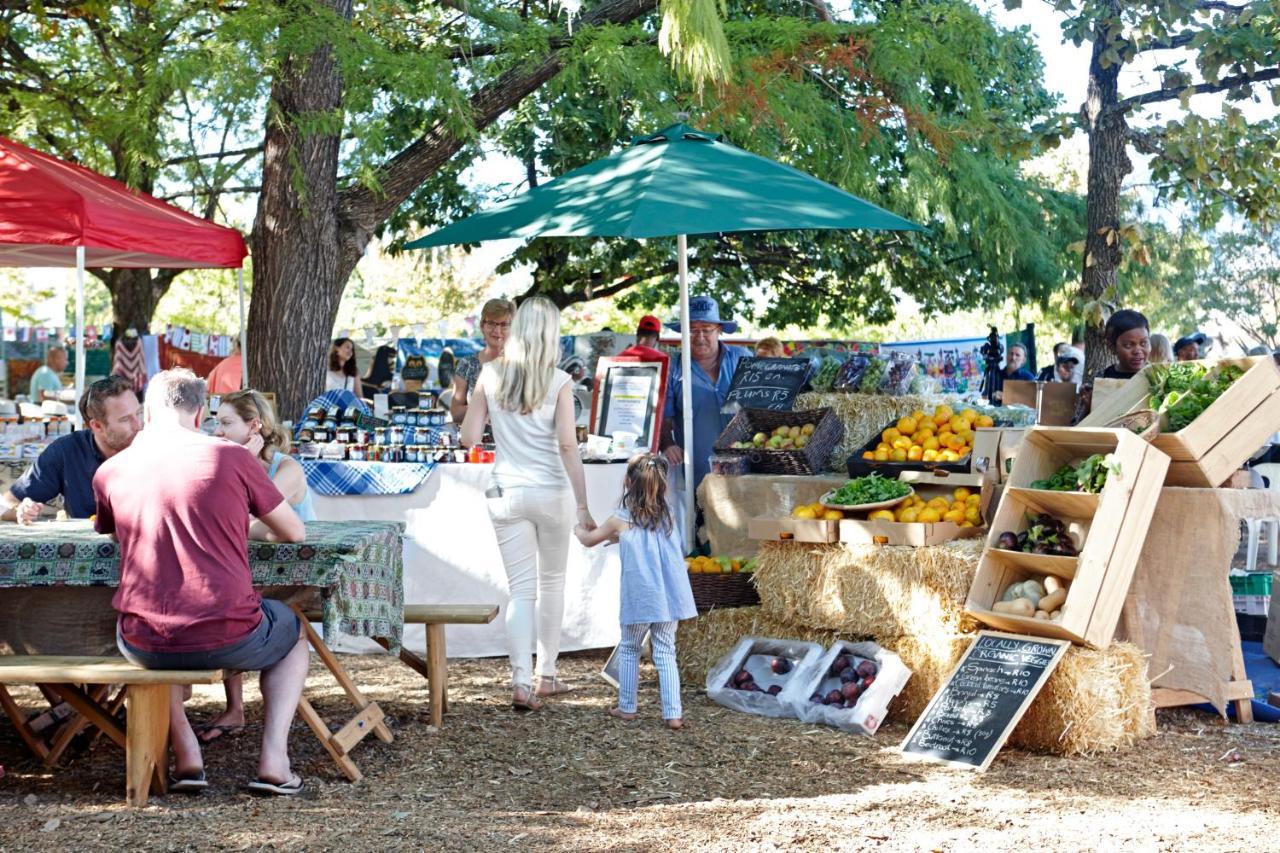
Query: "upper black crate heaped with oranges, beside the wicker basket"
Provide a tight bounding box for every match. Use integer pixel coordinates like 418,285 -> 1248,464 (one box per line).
849,405 -> 996,476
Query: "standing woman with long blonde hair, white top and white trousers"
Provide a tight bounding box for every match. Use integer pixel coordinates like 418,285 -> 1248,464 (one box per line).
462,296 -> 595,711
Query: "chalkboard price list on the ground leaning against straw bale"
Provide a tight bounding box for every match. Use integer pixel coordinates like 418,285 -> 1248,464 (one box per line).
902,631 -> 1071,771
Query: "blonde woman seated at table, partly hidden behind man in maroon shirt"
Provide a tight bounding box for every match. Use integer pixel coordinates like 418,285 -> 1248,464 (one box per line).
196,388 -> 316,743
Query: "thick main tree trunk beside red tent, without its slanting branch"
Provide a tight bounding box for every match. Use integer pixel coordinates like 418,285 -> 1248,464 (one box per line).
244,0 -> 352,420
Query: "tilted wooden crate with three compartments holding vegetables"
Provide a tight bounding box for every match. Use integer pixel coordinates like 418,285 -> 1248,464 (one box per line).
965,427 -> 1169,646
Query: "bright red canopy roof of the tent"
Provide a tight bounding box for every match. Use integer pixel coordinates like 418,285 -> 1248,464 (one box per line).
0,137 -> 248,269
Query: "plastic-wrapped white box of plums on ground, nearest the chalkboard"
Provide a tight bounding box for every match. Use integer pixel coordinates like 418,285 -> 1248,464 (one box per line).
781,640 -> 911,735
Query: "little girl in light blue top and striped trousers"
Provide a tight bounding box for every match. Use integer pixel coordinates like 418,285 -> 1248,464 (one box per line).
573,453 -> 698,729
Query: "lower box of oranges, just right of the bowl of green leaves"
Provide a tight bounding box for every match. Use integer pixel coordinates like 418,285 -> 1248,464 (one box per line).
838,475 -> 991,547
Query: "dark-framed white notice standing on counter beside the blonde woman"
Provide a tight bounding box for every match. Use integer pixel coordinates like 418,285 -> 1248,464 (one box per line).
589,356 -> 671,453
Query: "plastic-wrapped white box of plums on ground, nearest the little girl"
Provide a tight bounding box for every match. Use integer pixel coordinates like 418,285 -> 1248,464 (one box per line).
707,637 -> 823,717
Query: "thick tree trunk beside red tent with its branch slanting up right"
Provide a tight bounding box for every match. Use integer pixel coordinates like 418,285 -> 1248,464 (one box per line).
246,0 -> 657,419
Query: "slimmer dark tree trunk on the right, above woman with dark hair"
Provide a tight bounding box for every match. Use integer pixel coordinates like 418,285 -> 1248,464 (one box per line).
1080,0 -> 1133,377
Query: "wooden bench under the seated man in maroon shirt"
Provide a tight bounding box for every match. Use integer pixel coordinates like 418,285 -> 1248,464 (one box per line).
0,654 -> 224,806
